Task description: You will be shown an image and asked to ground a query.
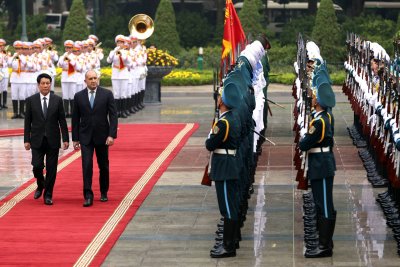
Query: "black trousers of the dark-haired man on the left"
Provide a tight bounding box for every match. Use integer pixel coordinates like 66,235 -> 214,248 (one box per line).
31,137 -> 59,198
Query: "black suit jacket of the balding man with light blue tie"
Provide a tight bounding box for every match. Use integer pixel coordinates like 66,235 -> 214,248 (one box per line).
72,87 -> 118,145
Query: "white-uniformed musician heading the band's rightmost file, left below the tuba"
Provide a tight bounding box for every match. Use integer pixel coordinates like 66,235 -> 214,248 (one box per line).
107,35 -> 132,118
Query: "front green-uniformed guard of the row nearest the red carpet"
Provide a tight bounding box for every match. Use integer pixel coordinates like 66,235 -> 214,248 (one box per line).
206,82 -> 242,258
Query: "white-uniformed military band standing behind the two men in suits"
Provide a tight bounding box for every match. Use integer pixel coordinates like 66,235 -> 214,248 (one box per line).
0,35 -> 147,119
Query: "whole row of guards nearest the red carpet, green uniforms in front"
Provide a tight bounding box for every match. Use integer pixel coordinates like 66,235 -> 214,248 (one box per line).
206,36 -> 270,258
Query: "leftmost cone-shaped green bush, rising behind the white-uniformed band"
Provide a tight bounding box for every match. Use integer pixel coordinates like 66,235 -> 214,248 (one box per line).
63,0 -> 89,41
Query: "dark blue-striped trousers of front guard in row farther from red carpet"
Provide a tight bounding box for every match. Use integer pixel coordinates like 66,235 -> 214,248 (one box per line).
311,177 -> 335,219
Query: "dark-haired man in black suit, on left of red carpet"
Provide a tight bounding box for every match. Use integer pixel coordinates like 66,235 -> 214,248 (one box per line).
24,73 -> 69,205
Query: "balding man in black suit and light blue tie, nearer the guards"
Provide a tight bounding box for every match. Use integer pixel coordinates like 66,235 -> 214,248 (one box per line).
72,70 -> 118,207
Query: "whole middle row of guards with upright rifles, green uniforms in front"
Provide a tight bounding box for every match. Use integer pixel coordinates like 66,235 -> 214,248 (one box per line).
292,34 -> 337,258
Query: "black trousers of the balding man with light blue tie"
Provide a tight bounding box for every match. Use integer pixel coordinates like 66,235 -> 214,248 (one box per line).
81,142 -> 110,199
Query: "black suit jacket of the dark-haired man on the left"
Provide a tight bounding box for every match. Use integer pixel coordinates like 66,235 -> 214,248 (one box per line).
24,93 -> 69,148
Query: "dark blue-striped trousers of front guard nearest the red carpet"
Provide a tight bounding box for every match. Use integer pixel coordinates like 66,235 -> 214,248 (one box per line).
215,180 -> 240,221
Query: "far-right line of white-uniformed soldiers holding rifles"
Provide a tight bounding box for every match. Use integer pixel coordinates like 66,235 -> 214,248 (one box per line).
343,33 -> 400,255
